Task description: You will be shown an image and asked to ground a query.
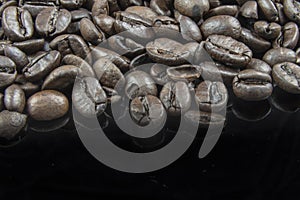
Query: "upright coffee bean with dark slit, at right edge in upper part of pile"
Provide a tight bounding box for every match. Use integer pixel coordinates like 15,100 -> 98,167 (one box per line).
273,22 -> 299,49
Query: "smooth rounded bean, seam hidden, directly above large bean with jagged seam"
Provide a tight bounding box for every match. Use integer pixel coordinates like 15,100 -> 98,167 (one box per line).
200,15 -> 242,39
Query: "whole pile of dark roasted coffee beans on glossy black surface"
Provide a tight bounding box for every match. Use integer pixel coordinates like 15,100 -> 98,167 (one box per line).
0,0 -> 300,140
